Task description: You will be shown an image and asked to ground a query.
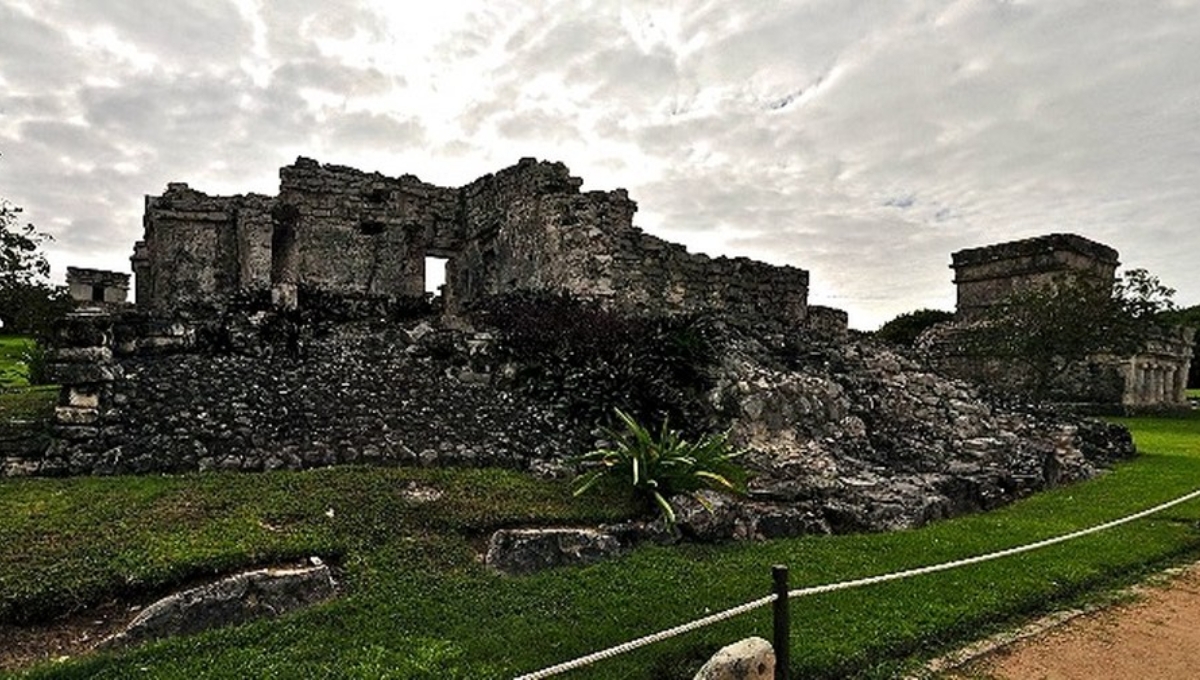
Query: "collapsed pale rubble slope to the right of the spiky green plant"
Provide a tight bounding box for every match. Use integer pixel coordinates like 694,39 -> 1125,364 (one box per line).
672,338 -> 1134,540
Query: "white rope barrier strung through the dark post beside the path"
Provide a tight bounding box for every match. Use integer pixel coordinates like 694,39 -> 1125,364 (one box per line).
516,489 -> 1200,680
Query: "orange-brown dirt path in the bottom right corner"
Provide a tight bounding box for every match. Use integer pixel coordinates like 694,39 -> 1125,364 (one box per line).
943,564 -> 1200,680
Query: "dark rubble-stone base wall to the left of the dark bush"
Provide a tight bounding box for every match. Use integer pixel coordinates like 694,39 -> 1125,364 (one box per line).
9,313 -> 586,476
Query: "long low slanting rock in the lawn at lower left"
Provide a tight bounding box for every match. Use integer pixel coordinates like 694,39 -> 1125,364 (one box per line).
103,565 -> 335,648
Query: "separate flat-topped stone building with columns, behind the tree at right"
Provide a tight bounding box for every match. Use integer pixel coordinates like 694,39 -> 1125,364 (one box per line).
923,234 -> 1195,410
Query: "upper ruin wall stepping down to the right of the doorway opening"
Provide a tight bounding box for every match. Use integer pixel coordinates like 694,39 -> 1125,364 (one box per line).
450,158 -> 809,327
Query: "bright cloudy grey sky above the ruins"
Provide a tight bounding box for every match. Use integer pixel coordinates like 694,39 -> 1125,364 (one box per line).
0,0 -> 1200,329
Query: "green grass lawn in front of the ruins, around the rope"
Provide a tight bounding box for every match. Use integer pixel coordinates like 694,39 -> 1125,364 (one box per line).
0,414 -> 1200,679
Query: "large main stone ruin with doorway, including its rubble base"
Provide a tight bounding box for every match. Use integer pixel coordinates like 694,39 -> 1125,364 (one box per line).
0,158 -> 1133,538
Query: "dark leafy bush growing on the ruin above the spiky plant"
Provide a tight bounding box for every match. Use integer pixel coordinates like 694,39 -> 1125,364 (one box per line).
476,291 -> 718,432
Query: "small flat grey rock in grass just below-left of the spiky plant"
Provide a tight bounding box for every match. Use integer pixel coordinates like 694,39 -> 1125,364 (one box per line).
486,529 -> 623,574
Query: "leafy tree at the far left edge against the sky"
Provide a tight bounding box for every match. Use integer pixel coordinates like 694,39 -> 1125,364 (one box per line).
0,199 -> 70,337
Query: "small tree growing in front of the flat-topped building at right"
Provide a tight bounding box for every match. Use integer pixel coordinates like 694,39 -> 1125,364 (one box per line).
962,269 -> 1175,398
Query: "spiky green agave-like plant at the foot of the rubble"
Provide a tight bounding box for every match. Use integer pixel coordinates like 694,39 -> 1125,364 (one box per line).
575,409 -> 745,524
